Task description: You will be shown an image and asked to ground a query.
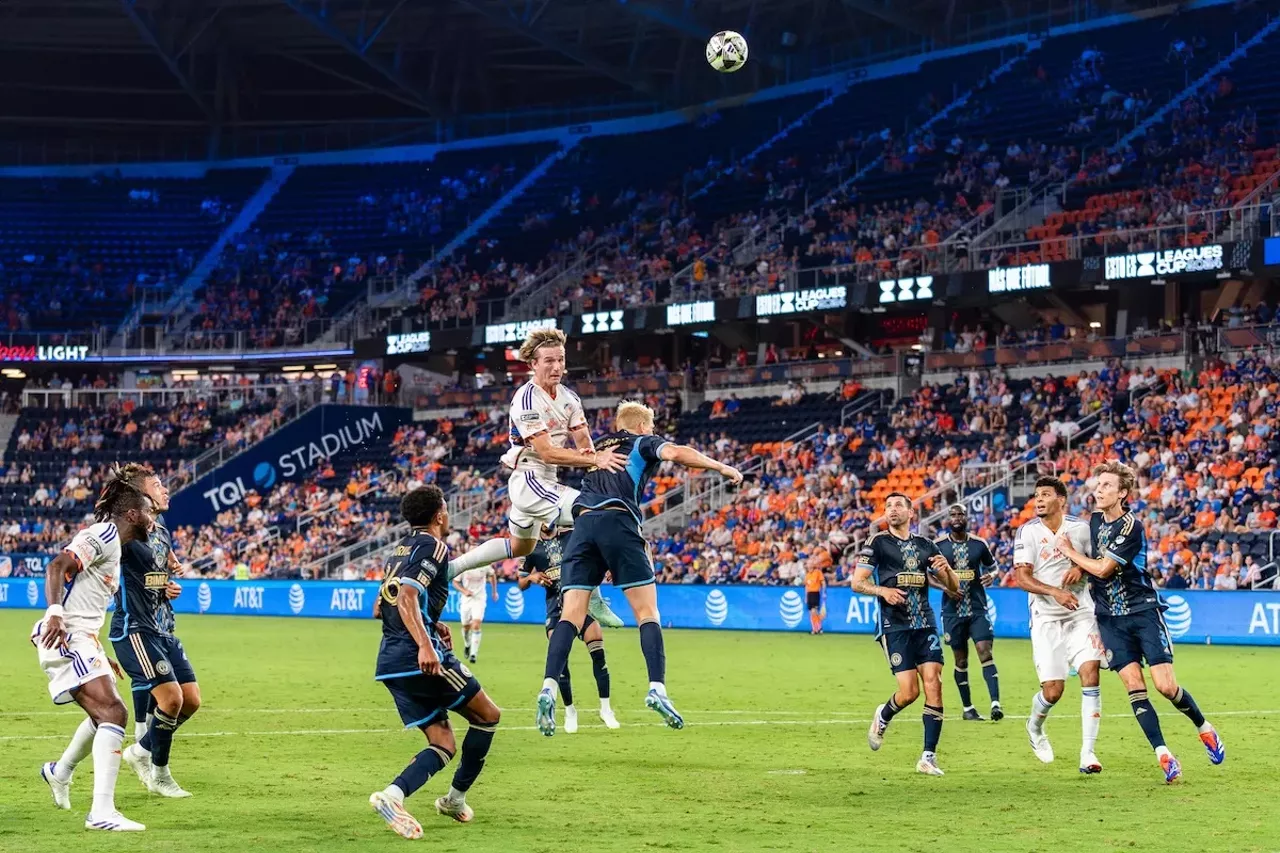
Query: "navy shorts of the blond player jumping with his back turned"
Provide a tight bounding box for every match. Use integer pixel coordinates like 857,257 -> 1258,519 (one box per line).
561,510 -> 654,589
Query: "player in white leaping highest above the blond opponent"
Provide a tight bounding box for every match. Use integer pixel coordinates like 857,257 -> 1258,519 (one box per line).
449,329 -> 623,628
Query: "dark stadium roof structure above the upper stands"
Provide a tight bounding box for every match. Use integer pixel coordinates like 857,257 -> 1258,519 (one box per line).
0,0 -> 1155,163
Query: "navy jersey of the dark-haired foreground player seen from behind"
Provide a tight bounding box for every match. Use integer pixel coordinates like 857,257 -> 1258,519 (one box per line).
376,530 -> 449,680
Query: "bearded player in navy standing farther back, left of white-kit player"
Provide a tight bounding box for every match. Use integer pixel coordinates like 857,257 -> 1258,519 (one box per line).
933,503 -> 1005,721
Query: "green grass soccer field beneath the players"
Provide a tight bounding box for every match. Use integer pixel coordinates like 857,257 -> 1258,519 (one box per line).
0,611 -> 1280,853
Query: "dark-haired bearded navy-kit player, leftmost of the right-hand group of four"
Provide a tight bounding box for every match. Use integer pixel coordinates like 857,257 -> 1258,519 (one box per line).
852,492 -> 960,776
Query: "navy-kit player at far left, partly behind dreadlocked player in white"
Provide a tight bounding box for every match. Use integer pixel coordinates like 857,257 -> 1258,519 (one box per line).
110,462 -> 200,797
